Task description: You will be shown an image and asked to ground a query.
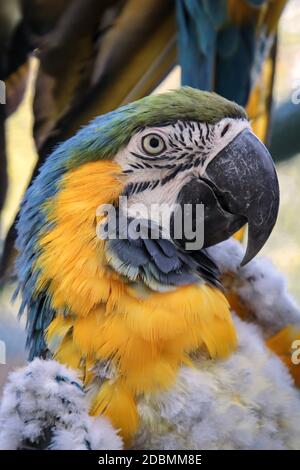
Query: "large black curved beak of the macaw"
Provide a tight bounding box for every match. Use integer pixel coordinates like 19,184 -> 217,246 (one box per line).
172,129 -> 279,266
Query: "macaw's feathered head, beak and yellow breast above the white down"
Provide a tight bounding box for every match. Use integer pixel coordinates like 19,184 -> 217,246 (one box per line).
17,87 -> 279,445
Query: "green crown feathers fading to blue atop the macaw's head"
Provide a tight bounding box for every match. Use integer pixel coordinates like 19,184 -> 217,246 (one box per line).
51,87 -> 247,170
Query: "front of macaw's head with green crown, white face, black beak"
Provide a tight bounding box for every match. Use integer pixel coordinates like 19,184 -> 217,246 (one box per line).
105,87 -> 279,264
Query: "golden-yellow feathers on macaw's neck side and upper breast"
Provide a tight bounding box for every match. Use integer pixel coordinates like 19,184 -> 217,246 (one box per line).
37,161 -> 236,443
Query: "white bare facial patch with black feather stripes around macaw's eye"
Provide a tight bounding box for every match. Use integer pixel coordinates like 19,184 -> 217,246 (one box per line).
114,118 -> 250,230
